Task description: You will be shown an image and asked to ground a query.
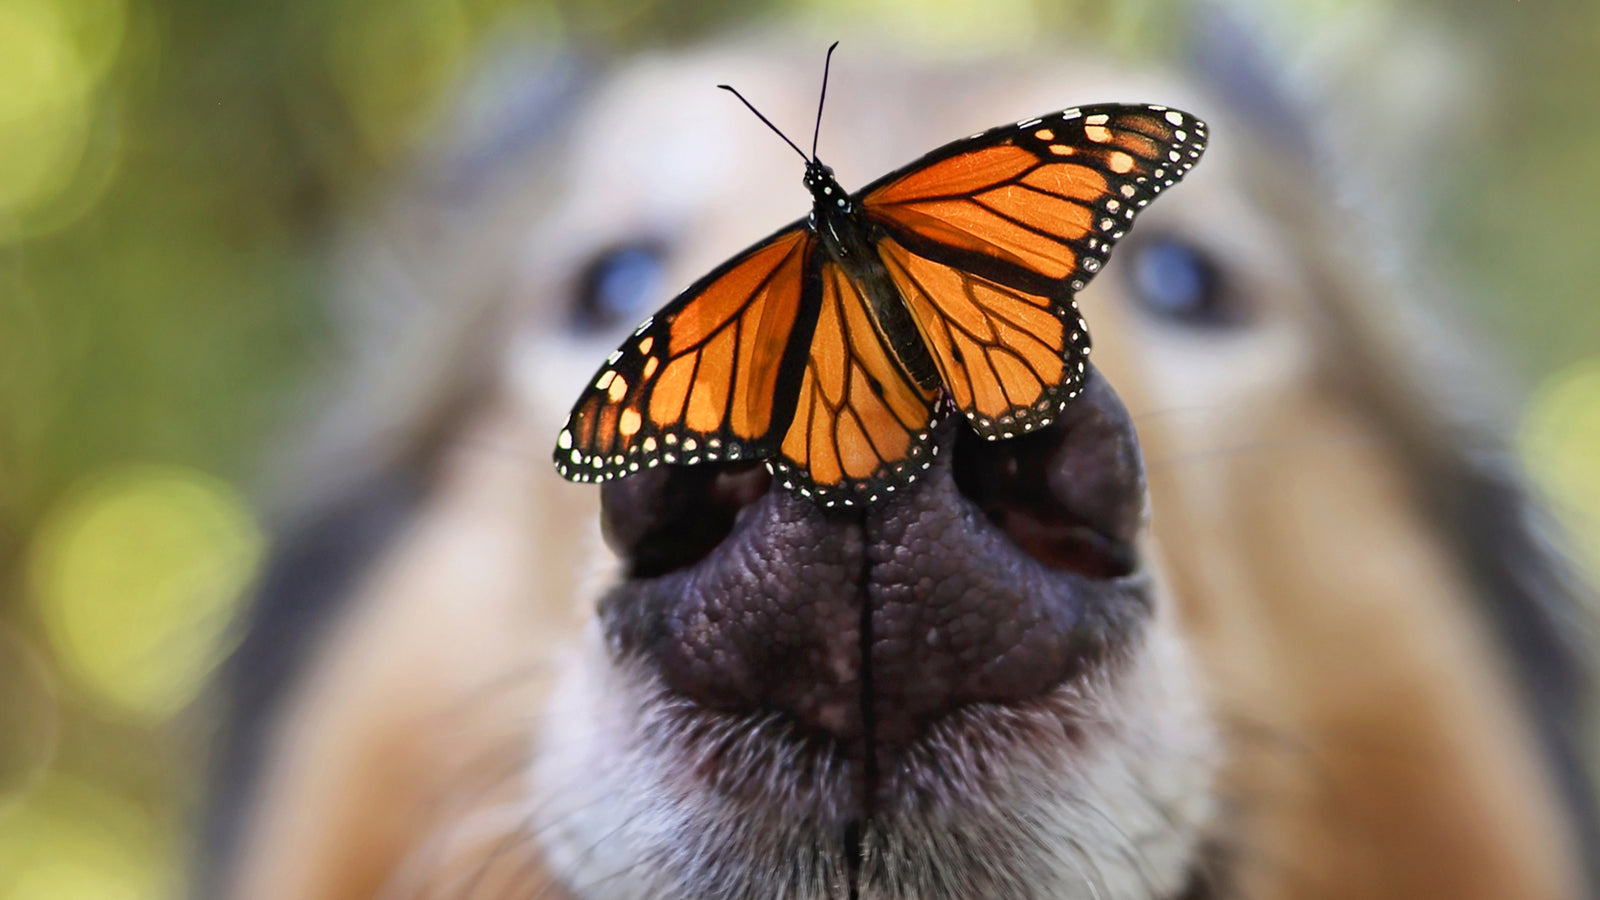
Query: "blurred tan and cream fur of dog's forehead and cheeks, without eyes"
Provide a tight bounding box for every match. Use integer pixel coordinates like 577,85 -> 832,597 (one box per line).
209,42 -> 1581,900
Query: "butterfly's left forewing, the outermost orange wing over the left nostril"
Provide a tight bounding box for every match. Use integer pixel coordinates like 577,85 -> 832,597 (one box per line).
555,227 -> 816,480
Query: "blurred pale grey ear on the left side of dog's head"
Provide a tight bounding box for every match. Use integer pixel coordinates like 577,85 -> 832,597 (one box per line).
262,42 -> 603,519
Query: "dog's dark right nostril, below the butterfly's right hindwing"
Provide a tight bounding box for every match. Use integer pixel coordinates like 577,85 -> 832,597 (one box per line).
952,373 -> 1144,578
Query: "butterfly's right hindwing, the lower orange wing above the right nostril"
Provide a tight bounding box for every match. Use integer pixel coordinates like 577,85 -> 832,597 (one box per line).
878,239 -> 1090,440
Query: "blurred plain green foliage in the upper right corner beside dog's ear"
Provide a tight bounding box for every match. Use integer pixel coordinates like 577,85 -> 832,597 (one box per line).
1427,0 -> 1600,373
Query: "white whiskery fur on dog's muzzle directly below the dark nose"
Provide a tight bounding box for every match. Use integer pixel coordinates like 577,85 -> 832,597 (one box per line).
531,595 -> 1218,900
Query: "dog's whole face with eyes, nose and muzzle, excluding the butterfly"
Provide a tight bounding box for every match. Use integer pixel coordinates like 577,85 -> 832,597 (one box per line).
209,40 -> 1578,900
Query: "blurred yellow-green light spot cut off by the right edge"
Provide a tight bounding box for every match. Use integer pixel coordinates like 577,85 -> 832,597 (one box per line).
1520,357 -> 1600,583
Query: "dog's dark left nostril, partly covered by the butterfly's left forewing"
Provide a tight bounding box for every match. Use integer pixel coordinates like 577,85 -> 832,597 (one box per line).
600,463 -> 771,578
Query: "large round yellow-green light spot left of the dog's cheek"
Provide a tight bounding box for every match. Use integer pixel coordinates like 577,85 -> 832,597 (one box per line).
29,466 -> 264,717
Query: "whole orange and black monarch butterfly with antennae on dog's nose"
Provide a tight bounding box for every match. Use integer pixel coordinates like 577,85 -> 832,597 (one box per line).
555,43 -> 1206,506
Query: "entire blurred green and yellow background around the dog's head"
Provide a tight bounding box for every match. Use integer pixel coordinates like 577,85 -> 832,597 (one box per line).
0,0 -> 1600,900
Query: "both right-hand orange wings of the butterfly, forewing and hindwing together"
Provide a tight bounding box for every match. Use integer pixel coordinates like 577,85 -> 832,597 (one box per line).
859,106 -> 1206,439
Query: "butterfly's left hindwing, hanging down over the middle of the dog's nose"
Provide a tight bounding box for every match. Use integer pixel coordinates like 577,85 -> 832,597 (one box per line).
771,263 -> 936,506
